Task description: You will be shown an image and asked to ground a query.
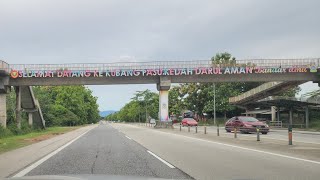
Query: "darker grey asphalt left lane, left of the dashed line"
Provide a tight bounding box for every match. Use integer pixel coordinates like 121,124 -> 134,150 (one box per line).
27,124 -> 191,179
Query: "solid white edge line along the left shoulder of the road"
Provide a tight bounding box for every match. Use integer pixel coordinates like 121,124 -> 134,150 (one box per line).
12,128 -> 93,178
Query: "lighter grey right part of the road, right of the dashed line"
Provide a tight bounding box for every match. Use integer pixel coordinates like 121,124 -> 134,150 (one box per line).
112,124 -> 320,180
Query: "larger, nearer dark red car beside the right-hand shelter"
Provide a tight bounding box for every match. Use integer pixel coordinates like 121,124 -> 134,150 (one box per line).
225,116 -> 269,134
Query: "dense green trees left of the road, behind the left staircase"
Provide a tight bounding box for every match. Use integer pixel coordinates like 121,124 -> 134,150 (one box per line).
7,86 -> 100,134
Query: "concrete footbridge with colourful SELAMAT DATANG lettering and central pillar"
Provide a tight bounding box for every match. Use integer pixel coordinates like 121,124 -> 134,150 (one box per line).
0,58 -> 320,129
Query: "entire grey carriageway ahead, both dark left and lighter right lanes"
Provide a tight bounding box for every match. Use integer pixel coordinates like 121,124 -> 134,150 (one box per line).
13,123 -> 320,180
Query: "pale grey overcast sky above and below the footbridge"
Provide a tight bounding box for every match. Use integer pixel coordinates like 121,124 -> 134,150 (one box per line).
0,0 -> 320,110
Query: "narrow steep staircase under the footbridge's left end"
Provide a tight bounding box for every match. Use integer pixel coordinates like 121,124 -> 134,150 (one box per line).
19,86 -> 45,128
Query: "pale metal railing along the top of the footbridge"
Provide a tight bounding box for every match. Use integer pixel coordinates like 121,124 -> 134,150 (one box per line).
0,58 -> 320,72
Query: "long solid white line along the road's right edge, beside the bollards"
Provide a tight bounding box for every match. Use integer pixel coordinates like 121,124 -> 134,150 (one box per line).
141,126 -> 320,165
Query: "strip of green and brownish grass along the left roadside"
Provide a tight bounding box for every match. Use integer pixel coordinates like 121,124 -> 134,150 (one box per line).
0,126 -> 82,154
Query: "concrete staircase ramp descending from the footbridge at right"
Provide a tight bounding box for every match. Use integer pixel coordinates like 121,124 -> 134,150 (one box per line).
229,81 -> 304,107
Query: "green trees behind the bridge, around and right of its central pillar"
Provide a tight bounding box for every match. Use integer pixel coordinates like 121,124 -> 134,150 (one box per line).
106,53 -> 300,122
